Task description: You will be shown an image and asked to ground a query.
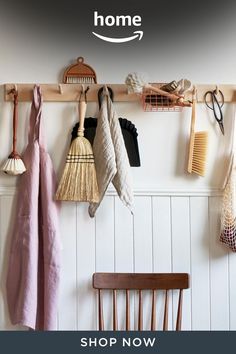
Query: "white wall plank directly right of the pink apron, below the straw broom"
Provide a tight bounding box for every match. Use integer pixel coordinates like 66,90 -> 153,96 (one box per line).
58,202 -> 77,330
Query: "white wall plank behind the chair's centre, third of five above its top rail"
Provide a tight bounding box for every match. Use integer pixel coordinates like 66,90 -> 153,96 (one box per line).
134,197 -> 153,330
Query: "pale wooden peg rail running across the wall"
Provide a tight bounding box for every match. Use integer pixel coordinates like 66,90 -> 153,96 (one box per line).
5,83 -> 236,103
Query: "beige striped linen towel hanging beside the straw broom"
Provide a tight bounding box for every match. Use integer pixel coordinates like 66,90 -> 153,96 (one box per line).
89,87 -> 133,217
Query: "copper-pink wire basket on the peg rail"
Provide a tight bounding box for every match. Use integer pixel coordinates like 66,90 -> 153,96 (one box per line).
142,83 -> 183,112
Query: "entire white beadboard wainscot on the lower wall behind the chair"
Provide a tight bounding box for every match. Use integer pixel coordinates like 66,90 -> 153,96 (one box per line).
0,191 -> 236,330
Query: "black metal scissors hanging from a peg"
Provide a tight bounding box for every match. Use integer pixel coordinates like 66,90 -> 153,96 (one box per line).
204,90 -> 225,135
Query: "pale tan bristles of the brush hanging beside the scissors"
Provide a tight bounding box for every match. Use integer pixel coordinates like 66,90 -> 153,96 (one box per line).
192,131 -> 208,176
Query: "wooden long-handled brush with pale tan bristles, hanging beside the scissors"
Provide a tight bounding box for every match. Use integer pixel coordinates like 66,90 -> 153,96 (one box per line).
188,89 -> 208,176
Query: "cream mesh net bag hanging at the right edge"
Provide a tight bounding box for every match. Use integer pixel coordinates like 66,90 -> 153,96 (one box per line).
220,110 -> 236,252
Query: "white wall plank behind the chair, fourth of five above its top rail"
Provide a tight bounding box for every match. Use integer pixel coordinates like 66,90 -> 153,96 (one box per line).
152,197 -> 172,330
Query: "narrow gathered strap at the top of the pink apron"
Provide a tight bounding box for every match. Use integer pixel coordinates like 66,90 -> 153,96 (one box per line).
28,85 -> 45,146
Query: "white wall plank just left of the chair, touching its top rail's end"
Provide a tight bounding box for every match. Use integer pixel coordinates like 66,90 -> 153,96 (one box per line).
77,203 -> 97,330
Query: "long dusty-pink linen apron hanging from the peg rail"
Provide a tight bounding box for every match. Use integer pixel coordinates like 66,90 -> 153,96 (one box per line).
7,86 -> 61,330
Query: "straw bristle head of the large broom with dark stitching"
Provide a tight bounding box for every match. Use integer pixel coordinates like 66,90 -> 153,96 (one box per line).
56,137 -> 99,203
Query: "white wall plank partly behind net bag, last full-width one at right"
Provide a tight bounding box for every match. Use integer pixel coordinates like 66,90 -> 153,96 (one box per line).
209,197 -> 229,330
